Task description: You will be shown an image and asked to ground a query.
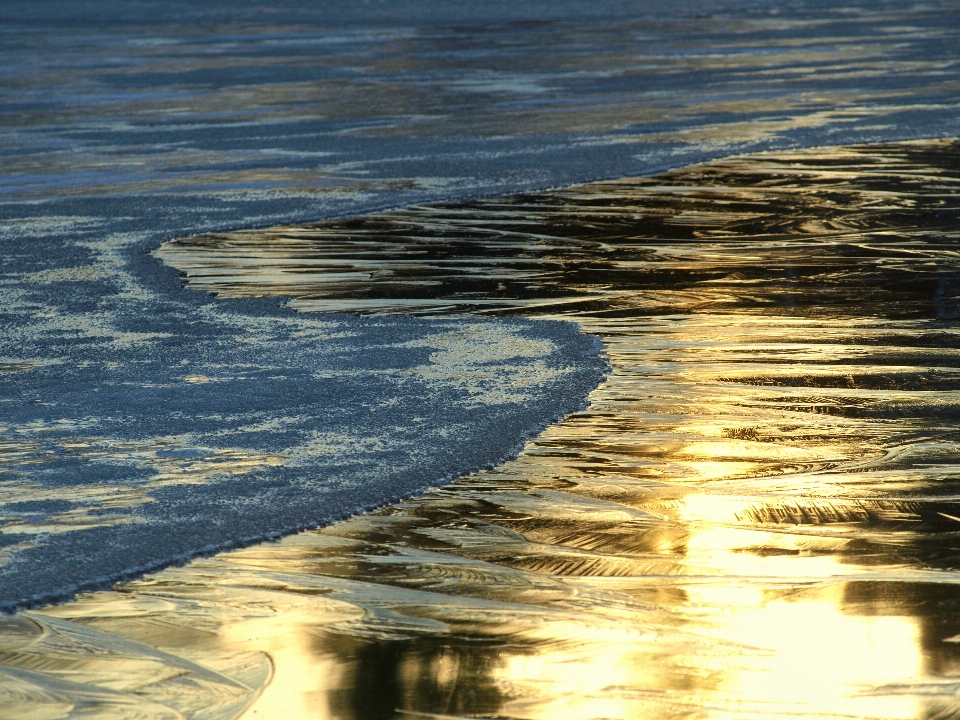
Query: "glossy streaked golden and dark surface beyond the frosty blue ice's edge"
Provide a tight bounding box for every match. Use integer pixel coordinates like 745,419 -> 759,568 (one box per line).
0,141 -> 960,720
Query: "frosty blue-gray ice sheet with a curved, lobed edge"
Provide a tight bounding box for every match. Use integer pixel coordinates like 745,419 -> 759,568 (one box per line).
0,0 -> 960,608
